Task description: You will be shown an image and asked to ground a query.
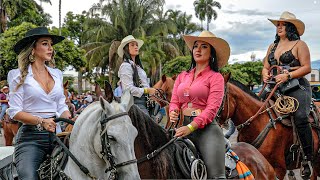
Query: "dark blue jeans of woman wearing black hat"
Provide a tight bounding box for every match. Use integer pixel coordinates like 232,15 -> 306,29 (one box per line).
14,125 -> 54,180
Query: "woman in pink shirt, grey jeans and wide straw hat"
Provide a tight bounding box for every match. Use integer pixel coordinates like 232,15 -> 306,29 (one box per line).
169,31 -> 230,179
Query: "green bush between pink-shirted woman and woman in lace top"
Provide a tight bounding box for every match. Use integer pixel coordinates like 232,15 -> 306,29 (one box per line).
220,61 -> 263,87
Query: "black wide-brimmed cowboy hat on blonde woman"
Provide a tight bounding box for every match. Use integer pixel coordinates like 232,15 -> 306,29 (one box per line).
13,27 -> 65,54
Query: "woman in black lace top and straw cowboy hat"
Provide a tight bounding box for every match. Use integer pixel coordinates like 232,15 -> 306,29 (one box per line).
262,11 -> 313,177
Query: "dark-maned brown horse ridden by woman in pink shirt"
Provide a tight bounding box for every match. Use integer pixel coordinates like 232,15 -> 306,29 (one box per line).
129,105 -> 276,180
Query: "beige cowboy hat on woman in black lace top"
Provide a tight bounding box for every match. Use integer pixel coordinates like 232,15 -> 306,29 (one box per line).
268,11 -> 305,36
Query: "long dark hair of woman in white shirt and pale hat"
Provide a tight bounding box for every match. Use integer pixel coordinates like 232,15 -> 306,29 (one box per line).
123,43 -> 143,87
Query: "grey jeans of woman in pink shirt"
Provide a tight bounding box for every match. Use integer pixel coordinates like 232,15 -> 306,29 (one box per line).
183,116 -> 225,179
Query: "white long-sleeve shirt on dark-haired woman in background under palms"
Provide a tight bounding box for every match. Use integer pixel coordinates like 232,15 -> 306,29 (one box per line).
118,60 -> 150,97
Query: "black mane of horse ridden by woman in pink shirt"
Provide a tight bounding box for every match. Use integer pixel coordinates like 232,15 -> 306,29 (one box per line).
128,105 -> 177,179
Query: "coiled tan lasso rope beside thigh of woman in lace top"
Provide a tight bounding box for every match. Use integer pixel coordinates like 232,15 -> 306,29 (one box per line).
275,96 -> 299,114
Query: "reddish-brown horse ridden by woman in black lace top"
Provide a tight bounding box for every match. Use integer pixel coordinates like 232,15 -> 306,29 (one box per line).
220,75 -> 320,179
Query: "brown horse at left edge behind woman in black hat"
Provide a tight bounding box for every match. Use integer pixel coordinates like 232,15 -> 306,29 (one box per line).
2,114 -> 19,146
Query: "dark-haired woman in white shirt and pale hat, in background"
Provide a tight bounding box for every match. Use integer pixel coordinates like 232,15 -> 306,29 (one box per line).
118,35 -> 155,115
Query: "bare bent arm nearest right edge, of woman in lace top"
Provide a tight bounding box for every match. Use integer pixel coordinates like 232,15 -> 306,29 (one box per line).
290,40 -> 311,78
